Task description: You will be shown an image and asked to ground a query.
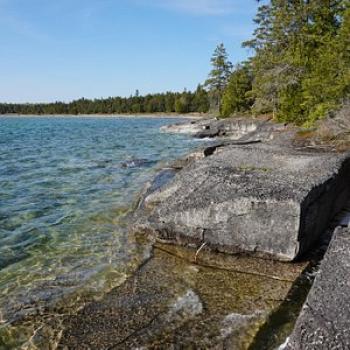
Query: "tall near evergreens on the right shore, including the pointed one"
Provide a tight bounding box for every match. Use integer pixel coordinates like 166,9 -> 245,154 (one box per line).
206,0 -> 350,126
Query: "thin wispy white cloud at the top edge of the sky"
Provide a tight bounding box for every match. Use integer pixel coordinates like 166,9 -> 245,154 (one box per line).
139,0 -> 235,16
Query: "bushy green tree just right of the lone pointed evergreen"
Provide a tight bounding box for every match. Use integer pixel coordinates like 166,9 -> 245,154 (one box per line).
220,64 -> 252,118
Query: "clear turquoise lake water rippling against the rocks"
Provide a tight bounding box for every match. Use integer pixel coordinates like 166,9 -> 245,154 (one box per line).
0,117 -> 202,344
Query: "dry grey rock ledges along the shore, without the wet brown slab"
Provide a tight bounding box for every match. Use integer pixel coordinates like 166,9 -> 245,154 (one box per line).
129,119 -> 350,349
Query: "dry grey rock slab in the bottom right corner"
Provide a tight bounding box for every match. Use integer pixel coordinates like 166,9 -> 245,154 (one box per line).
287,228 -> 350,350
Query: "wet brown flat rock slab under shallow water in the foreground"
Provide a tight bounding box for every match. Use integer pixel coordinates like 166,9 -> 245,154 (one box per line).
58,246 -> 305,350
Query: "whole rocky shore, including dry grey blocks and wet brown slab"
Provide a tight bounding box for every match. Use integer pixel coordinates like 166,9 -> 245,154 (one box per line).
37,119 -> 350,350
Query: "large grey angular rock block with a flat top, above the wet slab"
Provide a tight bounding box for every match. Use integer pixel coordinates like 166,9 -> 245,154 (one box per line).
134,144 -> 350,261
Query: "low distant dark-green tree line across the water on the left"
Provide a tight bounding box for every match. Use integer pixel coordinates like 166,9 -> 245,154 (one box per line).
0,85 -> 209,115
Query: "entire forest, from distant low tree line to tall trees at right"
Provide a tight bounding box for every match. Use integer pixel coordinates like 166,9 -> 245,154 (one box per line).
0,0 -> 350,126
